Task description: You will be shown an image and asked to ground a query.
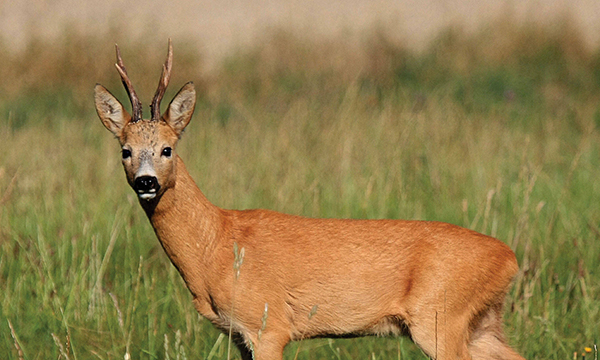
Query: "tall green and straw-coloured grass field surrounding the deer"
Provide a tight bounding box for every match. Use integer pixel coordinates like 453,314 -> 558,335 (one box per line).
0,21 -> 600,359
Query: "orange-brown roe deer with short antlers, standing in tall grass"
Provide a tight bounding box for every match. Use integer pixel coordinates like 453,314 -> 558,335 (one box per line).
95,40 -> 523,360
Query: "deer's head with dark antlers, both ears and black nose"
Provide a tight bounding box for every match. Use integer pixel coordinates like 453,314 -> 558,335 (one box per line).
94,40 -> 196,200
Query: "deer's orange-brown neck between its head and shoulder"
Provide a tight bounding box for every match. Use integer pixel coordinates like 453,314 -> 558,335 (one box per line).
141,157 -> 221,295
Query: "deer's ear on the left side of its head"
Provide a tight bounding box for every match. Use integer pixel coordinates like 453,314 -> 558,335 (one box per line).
94,84 -> 131,137
